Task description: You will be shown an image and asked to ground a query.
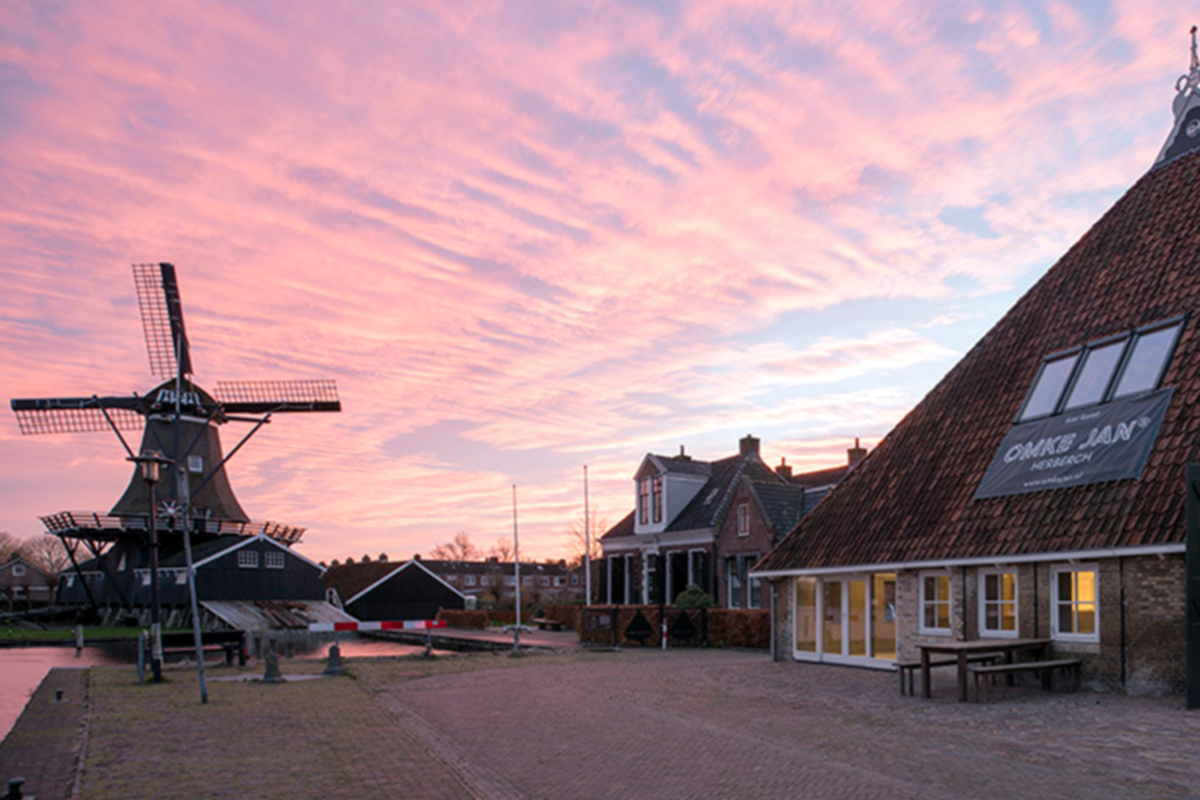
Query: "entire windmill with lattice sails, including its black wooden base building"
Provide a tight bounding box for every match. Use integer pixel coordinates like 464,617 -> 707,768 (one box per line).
12,264 -> 341,625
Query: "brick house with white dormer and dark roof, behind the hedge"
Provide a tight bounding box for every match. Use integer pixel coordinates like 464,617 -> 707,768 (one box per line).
593,435 -> 860,608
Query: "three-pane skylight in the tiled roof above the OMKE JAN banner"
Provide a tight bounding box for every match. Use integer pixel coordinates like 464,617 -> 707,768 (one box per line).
1016,319 -> 1183,422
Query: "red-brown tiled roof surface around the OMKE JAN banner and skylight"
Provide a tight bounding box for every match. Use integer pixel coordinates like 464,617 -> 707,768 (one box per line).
757,148 -> 1200,571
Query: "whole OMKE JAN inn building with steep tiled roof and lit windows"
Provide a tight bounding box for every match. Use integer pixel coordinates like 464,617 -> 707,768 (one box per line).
755,56 -> 1200,693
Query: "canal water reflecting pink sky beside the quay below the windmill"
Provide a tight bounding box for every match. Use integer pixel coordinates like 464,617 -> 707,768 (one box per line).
0,637 -> 422,741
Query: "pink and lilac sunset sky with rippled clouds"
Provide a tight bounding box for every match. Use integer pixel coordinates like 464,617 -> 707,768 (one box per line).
0,0 -> 1193,560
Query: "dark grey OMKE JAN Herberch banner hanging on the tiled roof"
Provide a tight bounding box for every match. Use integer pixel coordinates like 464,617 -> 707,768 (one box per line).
974,389 -> 1175,500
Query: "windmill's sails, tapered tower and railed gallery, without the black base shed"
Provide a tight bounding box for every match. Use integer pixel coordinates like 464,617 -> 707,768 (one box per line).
12,263 -> 341,607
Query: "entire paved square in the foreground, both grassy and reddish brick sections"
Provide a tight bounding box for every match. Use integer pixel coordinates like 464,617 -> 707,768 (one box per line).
6,649 -> 1200,800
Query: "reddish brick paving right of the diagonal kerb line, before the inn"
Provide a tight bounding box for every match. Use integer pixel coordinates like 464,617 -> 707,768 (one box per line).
362,650 -> 1200,800
